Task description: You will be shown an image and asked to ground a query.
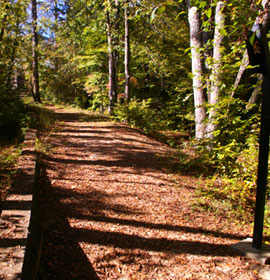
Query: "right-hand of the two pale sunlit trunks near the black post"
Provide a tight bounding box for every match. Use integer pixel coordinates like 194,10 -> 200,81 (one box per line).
208,1 -> 225,137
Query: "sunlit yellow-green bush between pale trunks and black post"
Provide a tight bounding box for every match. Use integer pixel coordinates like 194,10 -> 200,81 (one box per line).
195,98 -> 259,221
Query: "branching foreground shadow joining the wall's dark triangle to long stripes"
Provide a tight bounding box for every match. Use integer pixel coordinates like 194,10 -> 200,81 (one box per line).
40,167 -> 240,280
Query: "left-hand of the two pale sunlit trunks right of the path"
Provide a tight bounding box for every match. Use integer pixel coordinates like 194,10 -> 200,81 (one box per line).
188,5 -> 206,140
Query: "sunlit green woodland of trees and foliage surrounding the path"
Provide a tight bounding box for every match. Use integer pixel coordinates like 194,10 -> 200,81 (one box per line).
0,0 -> 270,236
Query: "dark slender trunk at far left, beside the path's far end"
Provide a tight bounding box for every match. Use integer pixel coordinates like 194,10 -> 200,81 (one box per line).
32,0 -> 41,103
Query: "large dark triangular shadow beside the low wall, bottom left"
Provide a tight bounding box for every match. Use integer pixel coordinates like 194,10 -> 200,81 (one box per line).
38,165 -> 99,280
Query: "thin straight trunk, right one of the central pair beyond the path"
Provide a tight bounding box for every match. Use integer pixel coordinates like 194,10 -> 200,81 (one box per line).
125,0 -> 130,101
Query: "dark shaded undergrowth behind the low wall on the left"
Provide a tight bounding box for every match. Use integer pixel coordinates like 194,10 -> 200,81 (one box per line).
0,94 -> 54,201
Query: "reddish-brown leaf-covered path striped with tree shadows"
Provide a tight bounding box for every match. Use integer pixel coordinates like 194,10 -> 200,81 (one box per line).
37,106 -> 260,280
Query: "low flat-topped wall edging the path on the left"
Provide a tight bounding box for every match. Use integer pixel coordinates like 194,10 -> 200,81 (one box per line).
0,129 -> 43,280
